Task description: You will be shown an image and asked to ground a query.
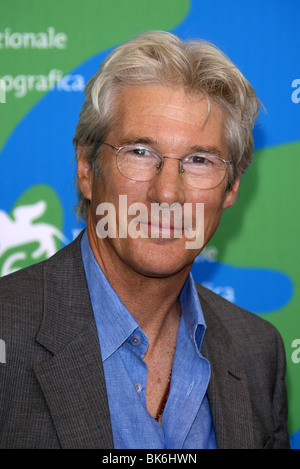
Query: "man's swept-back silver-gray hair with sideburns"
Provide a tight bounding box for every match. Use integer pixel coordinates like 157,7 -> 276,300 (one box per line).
73,31 -> 259,218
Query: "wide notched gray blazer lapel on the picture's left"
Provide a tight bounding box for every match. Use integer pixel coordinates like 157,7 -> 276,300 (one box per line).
34,238 -> 113,449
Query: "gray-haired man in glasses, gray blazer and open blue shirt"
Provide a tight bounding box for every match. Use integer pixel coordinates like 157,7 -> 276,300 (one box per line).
0,32 -> 289,449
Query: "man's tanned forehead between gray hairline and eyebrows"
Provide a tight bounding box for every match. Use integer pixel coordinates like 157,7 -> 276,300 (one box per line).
109,85 -> 225,152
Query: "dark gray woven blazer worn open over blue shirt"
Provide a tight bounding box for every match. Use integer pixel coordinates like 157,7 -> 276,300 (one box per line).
0,233 -> 289,449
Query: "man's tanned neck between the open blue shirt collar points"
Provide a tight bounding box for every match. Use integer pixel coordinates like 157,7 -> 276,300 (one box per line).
88,221 -> 190,338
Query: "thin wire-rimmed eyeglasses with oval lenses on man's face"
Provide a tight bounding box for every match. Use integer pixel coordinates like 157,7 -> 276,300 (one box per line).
101,142 -> 232,189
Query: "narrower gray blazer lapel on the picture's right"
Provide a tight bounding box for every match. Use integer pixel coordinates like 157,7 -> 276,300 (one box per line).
200,293 -> 254,449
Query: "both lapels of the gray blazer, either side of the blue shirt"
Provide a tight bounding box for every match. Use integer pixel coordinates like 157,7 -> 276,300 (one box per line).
34,232 -> 254,449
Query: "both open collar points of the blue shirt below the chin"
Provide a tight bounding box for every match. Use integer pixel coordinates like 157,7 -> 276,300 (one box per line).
81,231 -> 206,361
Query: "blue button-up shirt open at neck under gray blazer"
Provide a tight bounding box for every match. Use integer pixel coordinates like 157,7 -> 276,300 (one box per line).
81,232 -> 216,449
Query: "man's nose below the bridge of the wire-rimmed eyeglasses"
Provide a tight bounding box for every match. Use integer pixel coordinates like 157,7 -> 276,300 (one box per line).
148,157 -> 184,205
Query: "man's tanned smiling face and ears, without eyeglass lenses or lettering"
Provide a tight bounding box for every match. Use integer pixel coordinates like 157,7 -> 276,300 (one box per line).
78,85 -> 238,277
